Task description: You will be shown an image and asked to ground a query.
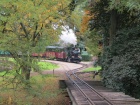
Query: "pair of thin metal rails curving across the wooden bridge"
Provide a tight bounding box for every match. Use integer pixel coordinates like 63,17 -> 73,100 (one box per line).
66,64 -> 114,105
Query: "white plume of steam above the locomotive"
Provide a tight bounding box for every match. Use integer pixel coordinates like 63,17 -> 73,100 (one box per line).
60,26 -> 77,45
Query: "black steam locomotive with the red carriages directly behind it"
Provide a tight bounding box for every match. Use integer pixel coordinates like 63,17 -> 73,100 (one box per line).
32,46 -> 82,63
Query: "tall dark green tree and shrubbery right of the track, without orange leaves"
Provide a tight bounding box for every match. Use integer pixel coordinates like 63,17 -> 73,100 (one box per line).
86,0 -> 140,98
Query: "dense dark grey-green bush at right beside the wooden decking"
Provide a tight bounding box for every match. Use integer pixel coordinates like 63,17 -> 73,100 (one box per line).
102,27 -> 140,98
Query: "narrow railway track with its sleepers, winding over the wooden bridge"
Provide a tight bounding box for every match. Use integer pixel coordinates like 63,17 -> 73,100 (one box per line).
66,64 -> 114,105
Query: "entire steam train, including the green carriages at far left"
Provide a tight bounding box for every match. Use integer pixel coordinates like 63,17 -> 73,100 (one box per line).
0,45 -> 90,63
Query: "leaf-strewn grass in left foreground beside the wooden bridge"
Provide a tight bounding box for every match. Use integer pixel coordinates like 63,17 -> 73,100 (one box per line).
0,75 -> 69,105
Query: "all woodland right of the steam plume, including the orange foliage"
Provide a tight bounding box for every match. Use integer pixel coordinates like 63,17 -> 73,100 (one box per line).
72,0 -> 140,98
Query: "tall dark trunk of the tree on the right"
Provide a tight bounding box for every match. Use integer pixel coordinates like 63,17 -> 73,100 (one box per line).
109,10 -> 117,46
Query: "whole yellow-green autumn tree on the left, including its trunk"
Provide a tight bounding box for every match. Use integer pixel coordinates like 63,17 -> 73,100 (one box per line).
0,0 -> 70,86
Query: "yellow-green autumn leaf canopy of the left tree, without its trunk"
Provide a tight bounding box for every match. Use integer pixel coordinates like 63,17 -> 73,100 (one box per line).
0,0 -> 69,52
